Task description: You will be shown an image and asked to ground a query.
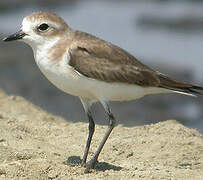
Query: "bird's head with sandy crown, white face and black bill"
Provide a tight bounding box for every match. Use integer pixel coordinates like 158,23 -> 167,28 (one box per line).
3,12 -> 70,47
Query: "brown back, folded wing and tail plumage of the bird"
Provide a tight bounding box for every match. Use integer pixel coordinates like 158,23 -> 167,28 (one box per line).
69,31 -> 203,95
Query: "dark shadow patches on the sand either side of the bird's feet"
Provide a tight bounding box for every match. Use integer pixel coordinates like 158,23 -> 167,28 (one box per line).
65,156 -> 122,171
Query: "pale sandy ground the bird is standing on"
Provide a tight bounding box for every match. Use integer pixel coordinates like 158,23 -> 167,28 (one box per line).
0,91 -> 203,180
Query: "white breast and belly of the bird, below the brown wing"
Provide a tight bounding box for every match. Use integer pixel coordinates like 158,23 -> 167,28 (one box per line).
37,54 -> 172,101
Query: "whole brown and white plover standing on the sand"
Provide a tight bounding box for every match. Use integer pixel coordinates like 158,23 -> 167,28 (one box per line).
3,12 -> 203,173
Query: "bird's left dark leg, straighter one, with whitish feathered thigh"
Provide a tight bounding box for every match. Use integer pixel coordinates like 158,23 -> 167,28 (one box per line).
81,99 -> 95,165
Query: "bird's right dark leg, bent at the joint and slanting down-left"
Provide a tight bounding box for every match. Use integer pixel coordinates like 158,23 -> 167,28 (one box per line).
85,102 -> 116,173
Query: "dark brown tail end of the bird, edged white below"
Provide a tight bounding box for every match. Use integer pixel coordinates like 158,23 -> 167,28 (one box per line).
159,74 -> 203,96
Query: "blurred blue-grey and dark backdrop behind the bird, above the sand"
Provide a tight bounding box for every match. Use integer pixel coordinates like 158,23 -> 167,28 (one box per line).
0,0 -> 203,132
